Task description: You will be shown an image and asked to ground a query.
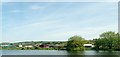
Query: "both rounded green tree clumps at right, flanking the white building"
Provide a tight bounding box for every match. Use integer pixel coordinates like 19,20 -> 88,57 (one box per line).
66,31 -> 120,51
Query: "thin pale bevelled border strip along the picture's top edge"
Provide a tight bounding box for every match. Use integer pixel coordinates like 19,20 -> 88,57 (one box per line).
2,0 -> 119,2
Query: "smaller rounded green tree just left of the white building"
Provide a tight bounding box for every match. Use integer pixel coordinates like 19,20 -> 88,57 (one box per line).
66,36 -> 84,51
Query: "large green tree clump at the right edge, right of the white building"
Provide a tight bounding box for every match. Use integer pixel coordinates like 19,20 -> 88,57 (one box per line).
95,31 -> 120,50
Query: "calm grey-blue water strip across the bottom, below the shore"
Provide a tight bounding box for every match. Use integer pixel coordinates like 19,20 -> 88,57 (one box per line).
0,50 -> 120,56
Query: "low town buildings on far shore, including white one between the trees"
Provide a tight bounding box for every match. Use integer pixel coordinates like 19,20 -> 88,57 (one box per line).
0,41 -> 94,50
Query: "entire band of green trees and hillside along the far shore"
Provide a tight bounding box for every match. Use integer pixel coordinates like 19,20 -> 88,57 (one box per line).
0,31 -> 120,51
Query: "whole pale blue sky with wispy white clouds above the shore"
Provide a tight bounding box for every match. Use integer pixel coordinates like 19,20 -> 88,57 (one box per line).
2,2 -> 118,42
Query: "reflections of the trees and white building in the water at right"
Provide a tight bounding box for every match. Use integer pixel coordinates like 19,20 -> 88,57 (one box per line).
67,50 -> 120,57
